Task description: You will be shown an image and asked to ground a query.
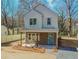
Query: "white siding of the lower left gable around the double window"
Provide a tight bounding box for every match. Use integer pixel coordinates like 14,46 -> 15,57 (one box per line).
24,10 -> 42,29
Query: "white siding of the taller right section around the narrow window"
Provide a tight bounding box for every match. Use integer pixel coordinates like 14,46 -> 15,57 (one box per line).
36,5 -> 58,29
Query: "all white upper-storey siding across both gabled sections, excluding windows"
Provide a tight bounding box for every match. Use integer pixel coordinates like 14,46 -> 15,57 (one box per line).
24,5 -> 58,30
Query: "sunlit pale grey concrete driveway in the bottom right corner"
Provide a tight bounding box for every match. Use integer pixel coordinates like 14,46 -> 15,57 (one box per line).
56,50 -> 78,59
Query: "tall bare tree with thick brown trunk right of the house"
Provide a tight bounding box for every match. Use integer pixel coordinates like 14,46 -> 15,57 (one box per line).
55,0 -> 78,36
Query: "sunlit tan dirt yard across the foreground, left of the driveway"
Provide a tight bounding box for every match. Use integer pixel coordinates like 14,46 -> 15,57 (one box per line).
1,47 -> 56,59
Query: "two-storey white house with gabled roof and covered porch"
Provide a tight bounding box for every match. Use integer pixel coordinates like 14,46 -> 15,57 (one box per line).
21,4 -> 58,47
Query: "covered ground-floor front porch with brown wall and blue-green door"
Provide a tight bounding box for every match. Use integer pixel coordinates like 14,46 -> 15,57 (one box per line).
21,29 -> 58,48
